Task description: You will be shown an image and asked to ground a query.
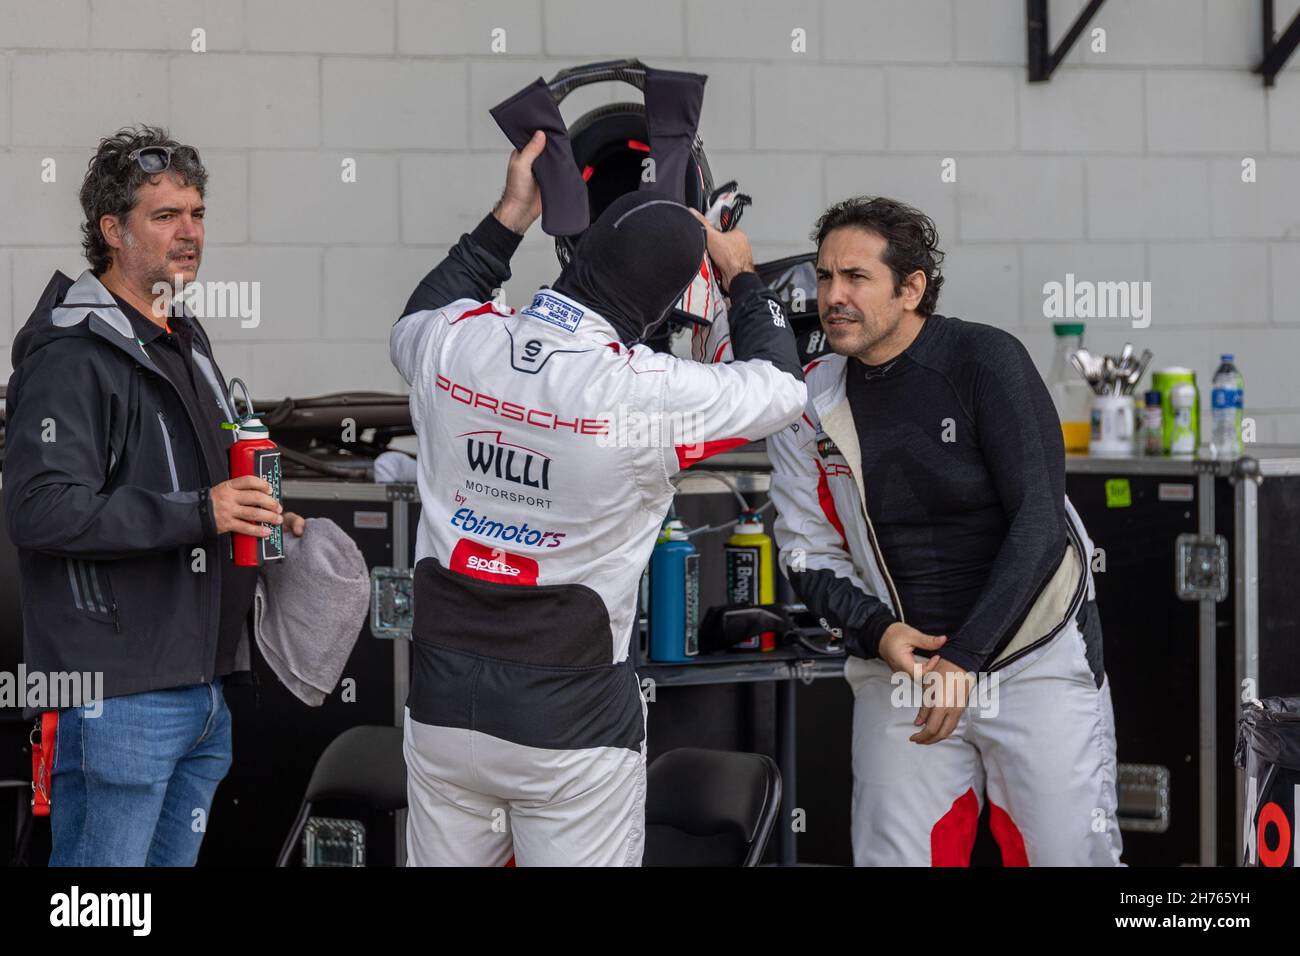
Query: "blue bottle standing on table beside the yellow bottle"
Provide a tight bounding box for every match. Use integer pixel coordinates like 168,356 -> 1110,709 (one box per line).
650,519 -> 699,663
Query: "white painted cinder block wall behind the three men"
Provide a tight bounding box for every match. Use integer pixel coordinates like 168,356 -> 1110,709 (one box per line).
0,0 -> 1300,442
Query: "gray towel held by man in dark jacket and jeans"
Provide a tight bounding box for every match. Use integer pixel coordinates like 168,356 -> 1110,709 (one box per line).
252,518 -> 371,708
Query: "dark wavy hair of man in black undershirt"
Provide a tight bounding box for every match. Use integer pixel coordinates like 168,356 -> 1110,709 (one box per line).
810,196 -> 944,317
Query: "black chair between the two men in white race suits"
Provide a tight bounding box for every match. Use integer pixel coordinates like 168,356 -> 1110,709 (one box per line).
644,747 -> 781,866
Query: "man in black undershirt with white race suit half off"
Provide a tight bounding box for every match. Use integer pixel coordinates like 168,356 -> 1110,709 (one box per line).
768,198 -> 1122,866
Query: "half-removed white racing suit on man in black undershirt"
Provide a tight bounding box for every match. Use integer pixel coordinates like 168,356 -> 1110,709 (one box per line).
767,355 -> 1121,866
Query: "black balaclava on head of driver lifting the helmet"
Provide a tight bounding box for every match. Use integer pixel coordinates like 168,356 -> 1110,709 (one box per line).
553,190 -> 706,345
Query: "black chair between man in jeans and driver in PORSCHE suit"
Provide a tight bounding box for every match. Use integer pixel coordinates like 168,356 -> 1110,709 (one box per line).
276,727 -> 407,866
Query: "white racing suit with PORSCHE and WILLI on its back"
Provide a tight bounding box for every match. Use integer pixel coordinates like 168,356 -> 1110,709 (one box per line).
391,216 -> 807,865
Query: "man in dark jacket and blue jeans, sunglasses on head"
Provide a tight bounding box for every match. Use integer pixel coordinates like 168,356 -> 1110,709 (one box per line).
4,126 -> 303,866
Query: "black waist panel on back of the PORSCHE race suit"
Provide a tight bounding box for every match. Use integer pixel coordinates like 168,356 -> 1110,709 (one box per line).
407,558 -> 645,750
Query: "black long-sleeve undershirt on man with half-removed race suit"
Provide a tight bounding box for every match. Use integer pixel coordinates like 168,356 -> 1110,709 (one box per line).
845,313 -> 1066,671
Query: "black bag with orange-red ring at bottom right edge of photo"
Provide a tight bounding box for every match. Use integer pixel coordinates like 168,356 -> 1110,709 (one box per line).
1234,697 -> 1300,866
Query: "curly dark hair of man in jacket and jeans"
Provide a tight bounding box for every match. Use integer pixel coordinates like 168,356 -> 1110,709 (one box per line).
81,126 -> 208,276
